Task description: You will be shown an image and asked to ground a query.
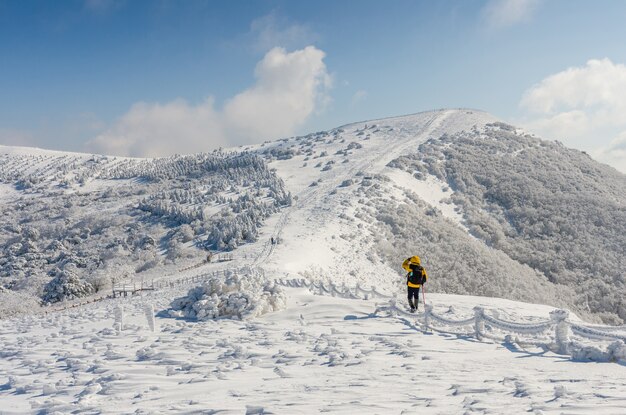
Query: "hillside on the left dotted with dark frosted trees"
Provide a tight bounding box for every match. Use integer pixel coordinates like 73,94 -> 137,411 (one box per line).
0,147 -> 290,312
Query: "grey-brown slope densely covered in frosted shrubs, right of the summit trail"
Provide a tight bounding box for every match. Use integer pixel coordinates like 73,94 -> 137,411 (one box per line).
390,123 -> 626,323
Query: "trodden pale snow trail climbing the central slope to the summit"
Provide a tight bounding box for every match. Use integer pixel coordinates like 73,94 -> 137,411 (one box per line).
246,110 -> 480,278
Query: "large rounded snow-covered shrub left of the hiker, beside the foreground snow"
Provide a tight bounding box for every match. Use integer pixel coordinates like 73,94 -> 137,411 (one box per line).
169,272 -> 287,320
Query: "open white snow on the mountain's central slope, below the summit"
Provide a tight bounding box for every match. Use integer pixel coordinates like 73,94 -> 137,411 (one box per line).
254,110 -> 488,288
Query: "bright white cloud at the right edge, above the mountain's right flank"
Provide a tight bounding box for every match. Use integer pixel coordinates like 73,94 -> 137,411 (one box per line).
520,58 -> 626,172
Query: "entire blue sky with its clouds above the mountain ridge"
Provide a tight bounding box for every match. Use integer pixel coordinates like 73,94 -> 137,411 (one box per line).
0,0 -> 626,171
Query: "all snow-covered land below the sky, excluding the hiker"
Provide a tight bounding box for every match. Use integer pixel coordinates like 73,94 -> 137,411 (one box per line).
0,109 -> 626,414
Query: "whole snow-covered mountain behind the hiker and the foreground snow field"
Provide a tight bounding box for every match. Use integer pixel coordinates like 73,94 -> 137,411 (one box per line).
0,110 -> 626,324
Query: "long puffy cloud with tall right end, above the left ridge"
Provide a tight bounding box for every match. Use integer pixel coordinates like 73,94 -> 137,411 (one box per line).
88,46 -> 331,157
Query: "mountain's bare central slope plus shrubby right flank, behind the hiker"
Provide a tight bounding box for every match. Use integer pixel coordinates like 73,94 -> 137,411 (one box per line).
247,110 -> 626,323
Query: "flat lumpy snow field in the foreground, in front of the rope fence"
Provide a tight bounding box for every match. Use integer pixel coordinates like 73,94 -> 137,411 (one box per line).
0,289 -> 626,414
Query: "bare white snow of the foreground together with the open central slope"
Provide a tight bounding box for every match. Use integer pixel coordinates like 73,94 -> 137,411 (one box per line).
0,111 -> 626,414
